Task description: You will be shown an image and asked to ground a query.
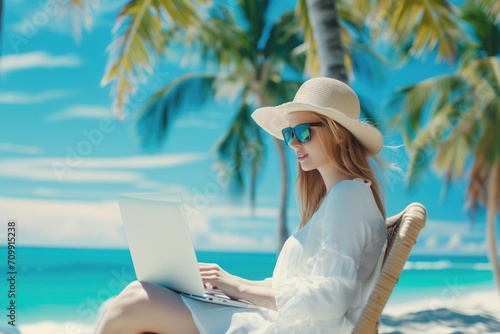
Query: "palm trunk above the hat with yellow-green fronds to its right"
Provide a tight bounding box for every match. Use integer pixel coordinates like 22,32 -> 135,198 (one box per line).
296,0 -> 464,74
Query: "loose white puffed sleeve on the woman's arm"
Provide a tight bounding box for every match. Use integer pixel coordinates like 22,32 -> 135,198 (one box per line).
275,181 -> 372,326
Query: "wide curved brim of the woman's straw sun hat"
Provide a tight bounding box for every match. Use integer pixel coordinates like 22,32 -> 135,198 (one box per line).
252,102 -> 383,155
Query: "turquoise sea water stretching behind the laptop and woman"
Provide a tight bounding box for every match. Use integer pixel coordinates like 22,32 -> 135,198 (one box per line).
0,247 -> 493,325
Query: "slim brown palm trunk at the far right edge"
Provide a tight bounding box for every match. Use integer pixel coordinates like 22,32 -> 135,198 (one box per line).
486,165 -> 500,292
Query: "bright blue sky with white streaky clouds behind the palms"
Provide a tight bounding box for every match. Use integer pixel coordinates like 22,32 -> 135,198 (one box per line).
0,0 -> 492,254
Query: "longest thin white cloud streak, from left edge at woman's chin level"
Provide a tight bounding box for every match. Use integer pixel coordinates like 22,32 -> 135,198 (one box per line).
0,153 -> 207,183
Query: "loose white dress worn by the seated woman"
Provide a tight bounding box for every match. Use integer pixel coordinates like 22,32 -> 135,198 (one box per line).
183,179 -> 386,334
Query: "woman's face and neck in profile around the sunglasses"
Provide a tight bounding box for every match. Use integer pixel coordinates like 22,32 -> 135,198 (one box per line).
288,111 -> 330,171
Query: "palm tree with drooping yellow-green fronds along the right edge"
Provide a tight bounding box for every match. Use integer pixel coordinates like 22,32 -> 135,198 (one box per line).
393,2 -> 500,291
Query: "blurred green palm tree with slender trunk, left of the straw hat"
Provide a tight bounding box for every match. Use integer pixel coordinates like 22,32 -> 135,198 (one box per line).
104,0 -> 305,252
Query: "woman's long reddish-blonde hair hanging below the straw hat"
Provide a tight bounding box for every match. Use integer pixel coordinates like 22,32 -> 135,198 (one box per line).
295,112 -> 386,228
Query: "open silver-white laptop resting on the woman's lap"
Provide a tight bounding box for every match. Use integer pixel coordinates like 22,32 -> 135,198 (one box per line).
118,193 -> 255,308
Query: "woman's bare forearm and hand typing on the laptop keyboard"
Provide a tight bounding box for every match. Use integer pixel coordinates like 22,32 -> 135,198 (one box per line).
199,263 -> 276,310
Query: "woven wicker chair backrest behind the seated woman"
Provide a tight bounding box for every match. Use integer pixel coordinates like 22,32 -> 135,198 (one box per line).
352,203 -> 427,334
